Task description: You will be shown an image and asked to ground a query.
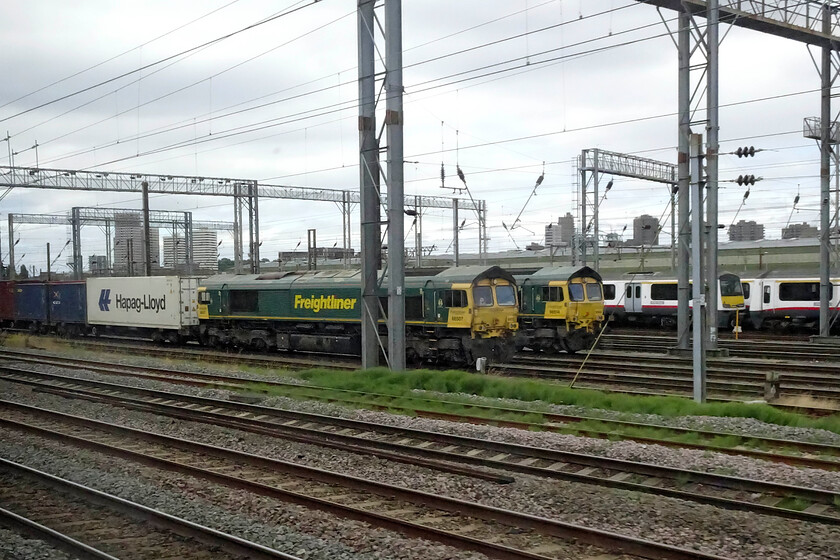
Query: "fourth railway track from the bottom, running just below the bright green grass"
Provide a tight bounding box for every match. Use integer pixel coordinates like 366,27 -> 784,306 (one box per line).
0,350 -> 840,470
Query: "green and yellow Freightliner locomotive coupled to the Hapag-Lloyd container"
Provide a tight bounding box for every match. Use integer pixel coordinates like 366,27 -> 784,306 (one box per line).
198,266 -> 518,364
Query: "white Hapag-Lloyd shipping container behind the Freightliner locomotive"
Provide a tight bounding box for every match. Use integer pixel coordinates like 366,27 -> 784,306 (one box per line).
87,276 -> 198,329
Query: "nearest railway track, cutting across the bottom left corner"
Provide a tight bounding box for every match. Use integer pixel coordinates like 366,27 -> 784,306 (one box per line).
0,458 -> 299,560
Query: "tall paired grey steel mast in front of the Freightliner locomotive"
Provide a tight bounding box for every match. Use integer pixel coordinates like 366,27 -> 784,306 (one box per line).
357,0 -> 411,371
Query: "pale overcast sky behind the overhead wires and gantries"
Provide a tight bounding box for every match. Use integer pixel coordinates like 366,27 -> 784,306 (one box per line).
0,0 -> 832,267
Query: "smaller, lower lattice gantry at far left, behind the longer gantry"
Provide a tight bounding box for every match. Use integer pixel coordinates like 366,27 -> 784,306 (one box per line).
9,206 -> 235,279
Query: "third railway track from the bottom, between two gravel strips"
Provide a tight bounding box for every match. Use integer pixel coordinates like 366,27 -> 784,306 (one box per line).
0,366 -> 840,524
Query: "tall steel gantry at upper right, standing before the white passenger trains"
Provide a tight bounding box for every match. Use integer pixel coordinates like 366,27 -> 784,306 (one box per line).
637,0 -> 840,398
